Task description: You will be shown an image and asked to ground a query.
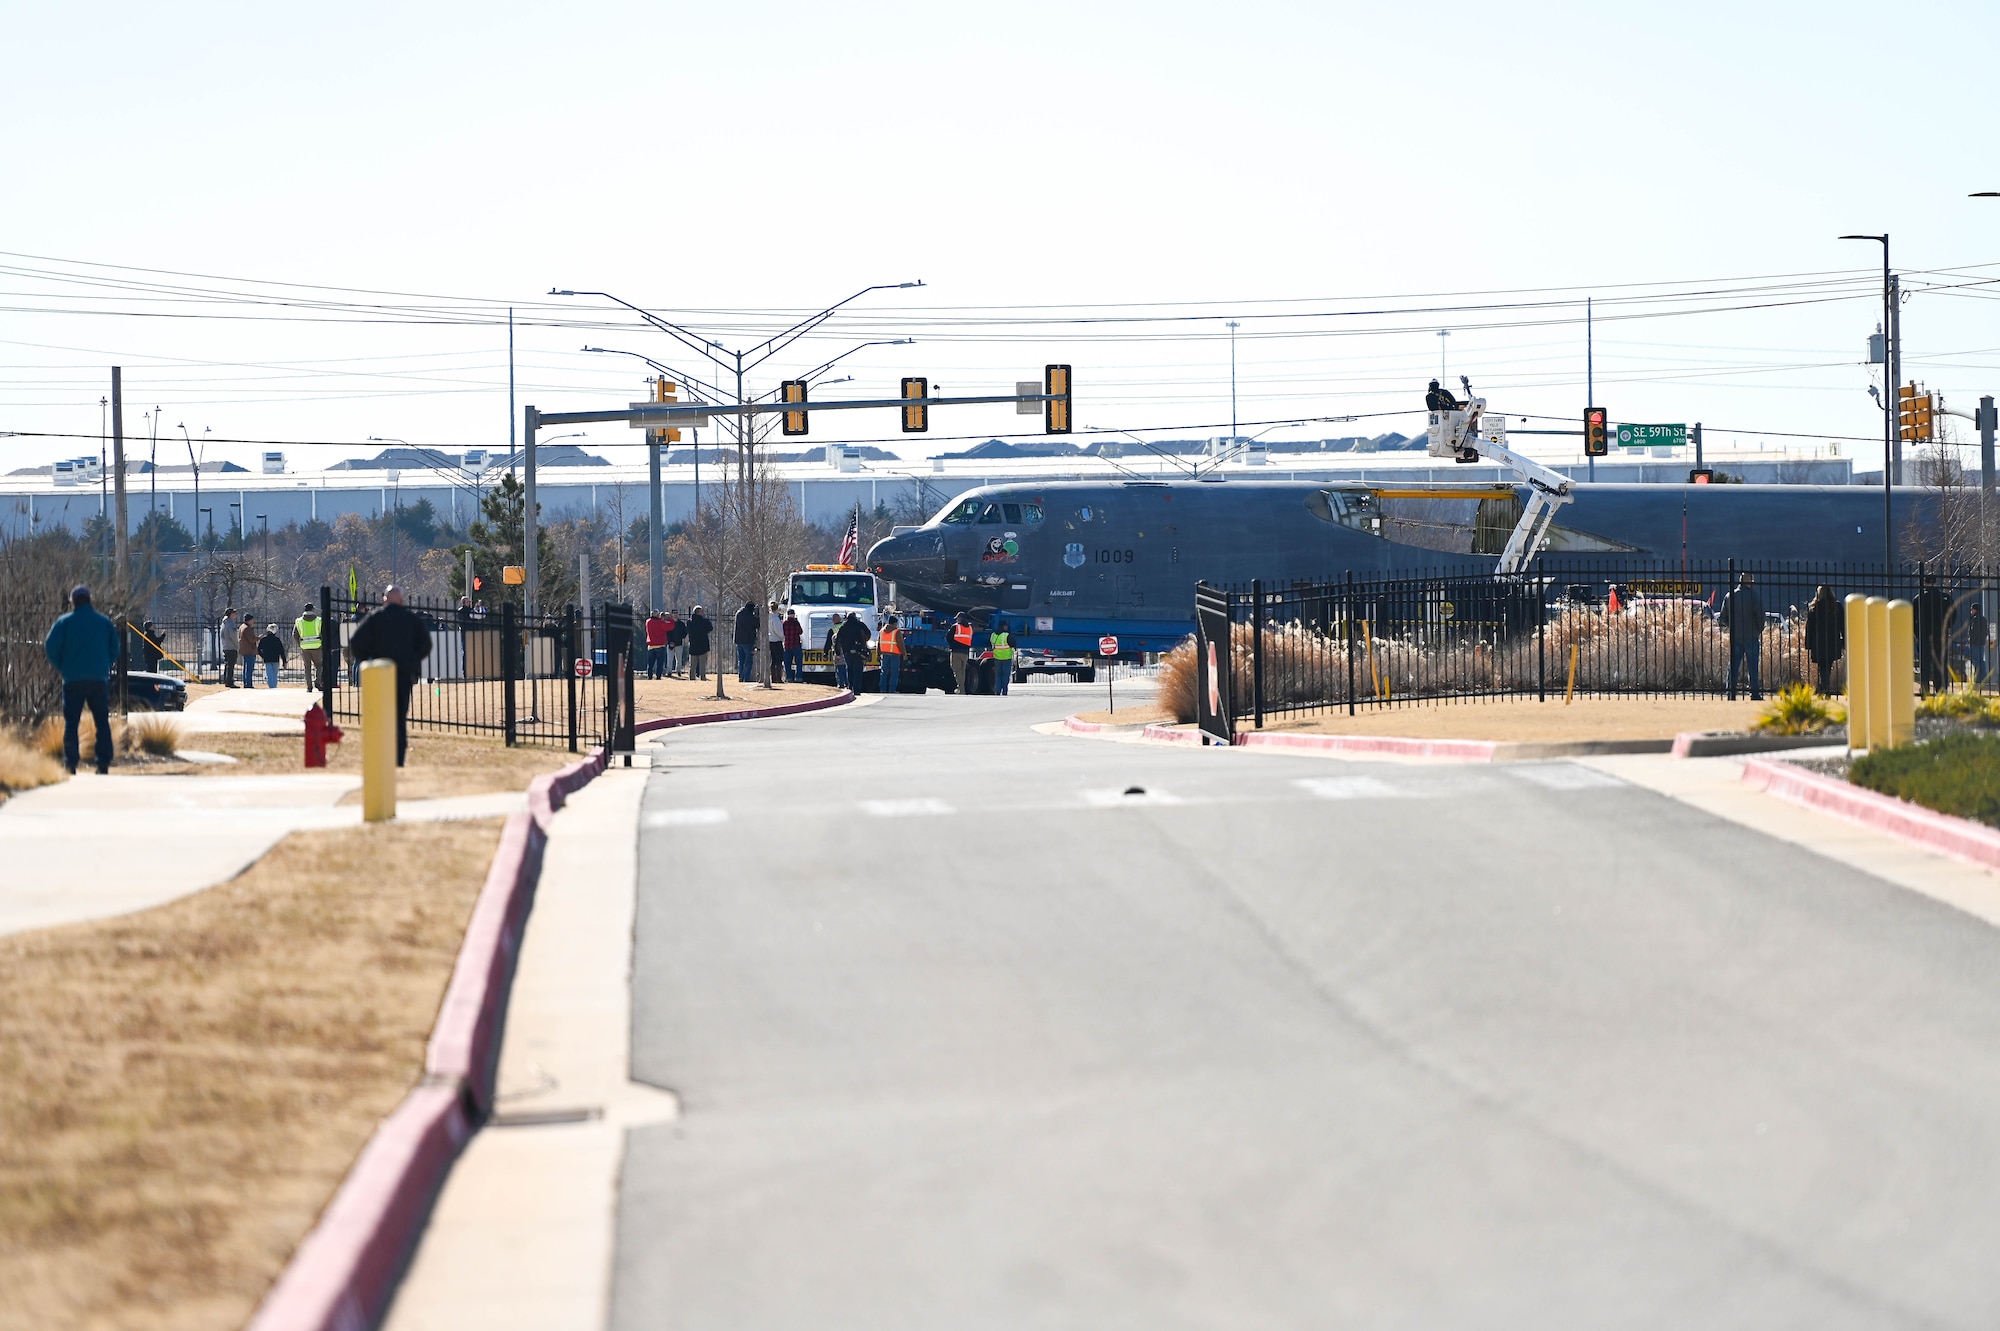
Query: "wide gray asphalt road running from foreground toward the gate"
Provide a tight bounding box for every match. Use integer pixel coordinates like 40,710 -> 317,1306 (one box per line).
614,689 -> 2000,1331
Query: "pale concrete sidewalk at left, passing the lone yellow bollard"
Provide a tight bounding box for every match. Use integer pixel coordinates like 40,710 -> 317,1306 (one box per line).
0,773 -> 526,933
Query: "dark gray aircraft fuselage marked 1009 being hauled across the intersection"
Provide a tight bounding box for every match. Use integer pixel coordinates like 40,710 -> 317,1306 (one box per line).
868,480 -> 1930,638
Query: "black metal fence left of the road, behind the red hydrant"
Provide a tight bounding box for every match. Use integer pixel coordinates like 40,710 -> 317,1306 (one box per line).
320,588 -> 638,753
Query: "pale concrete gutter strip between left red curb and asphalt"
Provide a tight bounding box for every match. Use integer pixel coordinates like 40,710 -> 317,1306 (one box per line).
384,751 -> 676,1331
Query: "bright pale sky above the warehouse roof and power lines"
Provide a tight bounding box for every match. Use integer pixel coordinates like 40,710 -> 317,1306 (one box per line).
0,2 -> 2000,470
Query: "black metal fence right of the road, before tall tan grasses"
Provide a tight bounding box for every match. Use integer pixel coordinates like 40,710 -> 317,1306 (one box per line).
1196,560 -> 2000,737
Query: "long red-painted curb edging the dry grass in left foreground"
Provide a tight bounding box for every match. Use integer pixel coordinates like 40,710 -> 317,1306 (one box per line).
250,749 -> 604,1331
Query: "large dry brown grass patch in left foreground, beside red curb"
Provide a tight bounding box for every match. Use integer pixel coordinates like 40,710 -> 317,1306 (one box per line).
0,821 -> 498,1331
